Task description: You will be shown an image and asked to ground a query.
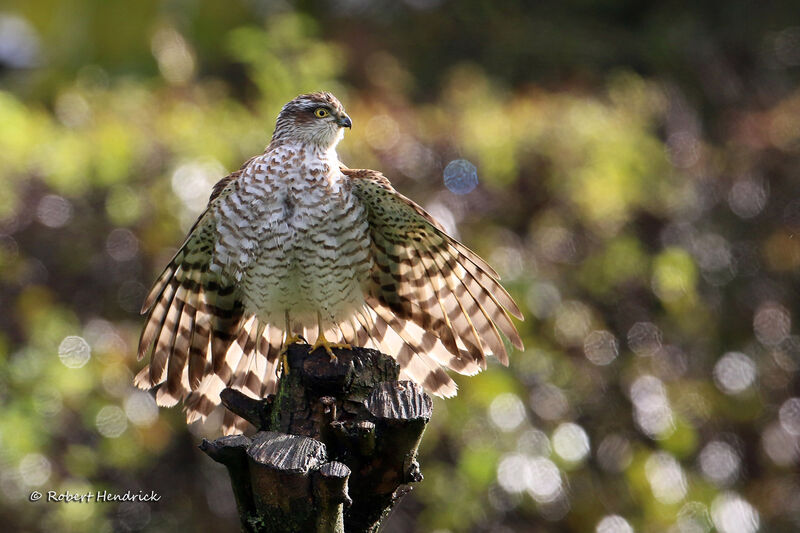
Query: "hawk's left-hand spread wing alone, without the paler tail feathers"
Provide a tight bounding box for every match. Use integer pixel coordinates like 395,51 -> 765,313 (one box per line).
135,171 -> 250,419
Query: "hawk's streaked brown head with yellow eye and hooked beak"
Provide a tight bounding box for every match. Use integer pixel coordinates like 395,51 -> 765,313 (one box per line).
272,92 -> 352,149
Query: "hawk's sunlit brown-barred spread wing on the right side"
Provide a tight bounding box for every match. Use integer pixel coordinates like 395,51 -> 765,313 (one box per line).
342,168 -> 523,396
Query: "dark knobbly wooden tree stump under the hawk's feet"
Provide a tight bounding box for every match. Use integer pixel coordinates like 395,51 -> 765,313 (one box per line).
200,344 -> 432,533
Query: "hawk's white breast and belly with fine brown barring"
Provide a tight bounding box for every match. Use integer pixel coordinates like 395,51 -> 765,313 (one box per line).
215,145 -> 372,325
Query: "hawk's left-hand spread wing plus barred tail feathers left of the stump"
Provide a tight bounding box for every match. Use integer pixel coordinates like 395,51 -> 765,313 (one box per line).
135,168 -> 283,433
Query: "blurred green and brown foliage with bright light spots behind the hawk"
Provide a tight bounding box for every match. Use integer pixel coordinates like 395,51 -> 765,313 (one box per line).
0,0 -> 800,533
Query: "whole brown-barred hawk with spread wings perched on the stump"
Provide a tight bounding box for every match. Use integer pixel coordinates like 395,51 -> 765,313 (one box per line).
135,92 -> 523,434
